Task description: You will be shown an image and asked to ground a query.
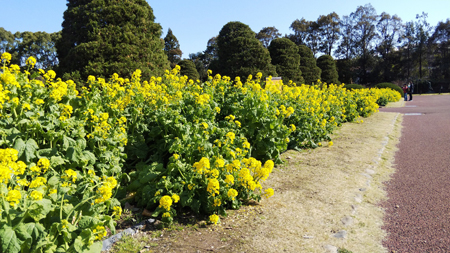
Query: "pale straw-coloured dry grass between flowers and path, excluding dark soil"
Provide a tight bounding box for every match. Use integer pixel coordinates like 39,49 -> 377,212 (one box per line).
237,113 -> 402,253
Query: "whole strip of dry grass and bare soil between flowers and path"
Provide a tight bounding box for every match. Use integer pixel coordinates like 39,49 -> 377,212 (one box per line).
111,105 -> 403,253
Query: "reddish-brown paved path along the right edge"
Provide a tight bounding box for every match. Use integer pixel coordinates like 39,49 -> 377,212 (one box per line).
380,95 -> 450,253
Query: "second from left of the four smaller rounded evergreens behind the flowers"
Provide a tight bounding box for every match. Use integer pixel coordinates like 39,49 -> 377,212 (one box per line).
268,38 -> 305,84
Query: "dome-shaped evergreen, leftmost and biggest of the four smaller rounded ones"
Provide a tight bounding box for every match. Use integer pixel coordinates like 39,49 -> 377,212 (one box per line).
212,22 -> 276,80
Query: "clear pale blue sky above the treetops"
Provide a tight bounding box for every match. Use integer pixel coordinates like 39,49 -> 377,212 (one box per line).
0,0 -> 450,58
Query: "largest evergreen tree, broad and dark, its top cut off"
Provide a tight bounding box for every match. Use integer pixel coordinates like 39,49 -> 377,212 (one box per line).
56,0 -> 169,80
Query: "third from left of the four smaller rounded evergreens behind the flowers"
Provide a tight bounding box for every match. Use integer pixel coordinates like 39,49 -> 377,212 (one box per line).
298,45 -> 322,84
